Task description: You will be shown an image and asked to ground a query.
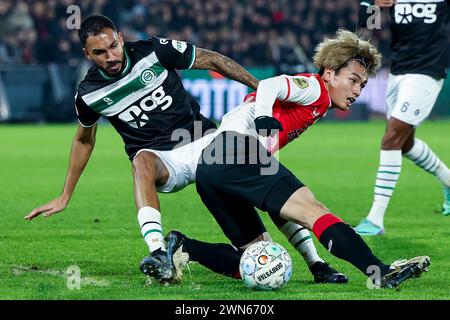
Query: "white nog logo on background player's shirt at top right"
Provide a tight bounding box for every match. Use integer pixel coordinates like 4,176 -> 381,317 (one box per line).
395,3 -> 437,24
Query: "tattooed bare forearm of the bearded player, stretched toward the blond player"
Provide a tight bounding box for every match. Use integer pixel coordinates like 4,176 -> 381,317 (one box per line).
192,48 -> 258,89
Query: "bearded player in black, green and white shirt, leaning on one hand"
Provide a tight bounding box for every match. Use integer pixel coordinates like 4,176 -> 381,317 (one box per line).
25,15 -> 347,283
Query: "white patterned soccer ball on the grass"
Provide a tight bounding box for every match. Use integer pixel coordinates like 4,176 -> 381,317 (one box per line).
239,241 -> 292,290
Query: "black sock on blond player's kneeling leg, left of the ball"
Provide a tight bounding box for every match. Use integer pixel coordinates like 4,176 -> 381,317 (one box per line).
183,238 -> 242,279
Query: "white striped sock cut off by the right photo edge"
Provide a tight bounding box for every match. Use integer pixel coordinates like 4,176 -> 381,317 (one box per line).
404,139 -> 450,187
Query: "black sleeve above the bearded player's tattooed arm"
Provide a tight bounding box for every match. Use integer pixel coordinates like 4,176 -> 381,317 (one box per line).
152,37 -> 195,69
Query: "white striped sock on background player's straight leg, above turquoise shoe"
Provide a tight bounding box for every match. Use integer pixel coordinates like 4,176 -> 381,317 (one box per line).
367,150 -> 402,227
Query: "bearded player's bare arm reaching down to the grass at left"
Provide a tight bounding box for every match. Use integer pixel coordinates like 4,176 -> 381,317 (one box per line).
25,125 -> 97,220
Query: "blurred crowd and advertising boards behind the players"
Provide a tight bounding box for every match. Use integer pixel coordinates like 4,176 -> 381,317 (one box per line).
0,0 -> 450,122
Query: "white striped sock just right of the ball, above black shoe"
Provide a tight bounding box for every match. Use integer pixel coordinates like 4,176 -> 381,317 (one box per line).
279,221 -> 323,267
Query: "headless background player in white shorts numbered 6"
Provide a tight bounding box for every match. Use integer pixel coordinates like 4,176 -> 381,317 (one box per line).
355,0 -> 450,235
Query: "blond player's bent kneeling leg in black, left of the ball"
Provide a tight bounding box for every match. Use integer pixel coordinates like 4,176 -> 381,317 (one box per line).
166,161 -> 270,278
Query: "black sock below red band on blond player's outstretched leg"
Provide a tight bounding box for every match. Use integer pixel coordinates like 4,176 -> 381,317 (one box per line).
316,219 -> 389,276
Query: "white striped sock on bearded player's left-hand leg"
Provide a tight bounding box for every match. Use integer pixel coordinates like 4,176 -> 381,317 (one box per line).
138,207 -> 166,253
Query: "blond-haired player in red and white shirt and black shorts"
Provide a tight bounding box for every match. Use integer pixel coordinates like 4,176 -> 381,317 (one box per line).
159,30 -> 430,287
